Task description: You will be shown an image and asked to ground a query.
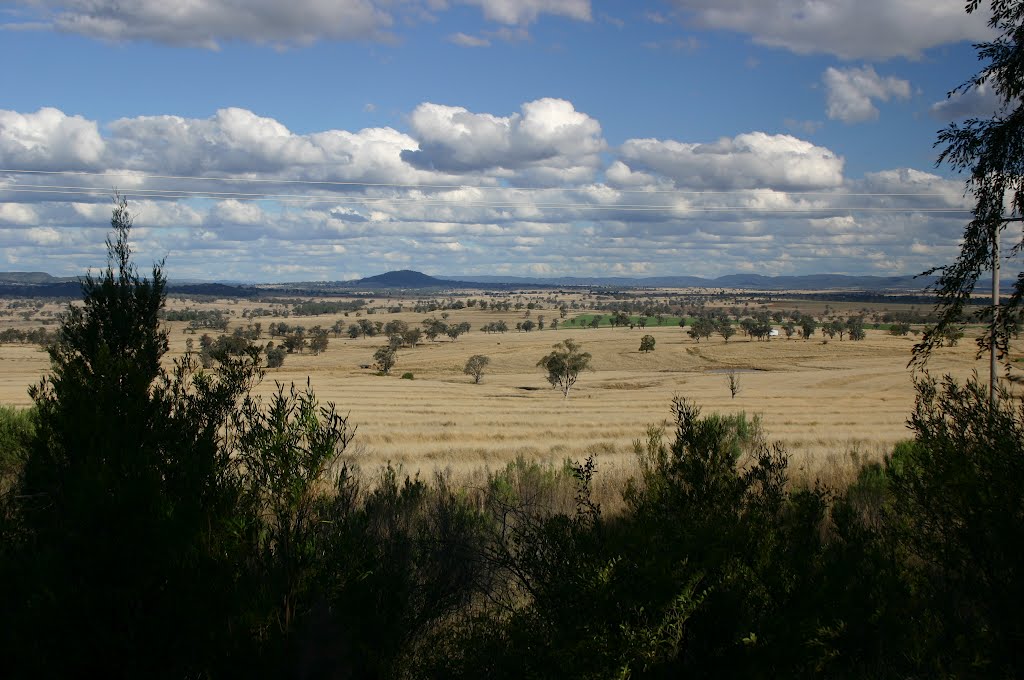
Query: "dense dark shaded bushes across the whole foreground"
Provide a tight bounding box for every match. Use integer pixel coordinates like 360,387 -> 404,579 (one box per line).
0,203 -> 1024,678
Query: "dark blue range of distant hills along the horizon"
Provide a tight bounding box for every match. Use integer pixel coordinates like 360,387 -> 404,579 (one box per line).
0,269 -> 950,298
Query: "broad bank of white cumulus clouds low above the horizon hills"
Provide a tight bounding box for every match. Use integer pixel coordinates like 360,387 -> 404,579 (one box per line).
0,99 -> 970,280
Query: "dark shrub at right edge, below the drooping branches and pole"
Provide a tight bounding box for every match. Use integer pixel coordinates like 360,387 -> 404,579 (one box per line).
889,377 -> 1024,677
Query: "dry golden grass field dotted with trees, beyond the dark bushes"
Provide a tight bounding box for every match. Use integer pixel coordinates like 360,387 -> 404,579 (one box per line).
0,292 -> 1007,493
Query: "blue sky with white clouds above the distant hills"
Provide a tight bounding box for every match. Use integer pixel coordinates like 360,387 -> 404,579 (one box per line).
0,0 -> 995,281
